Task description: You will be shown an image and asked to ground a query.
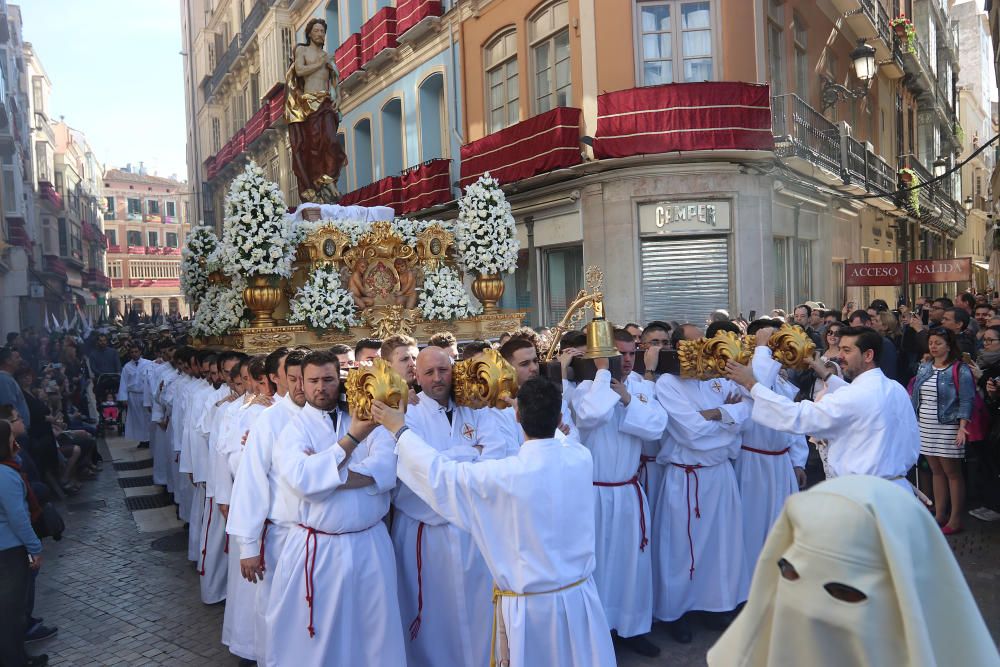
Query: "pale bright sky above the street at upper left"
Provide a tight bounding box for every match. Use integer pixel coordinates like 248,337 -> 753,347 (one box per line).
18,0 -> 187,180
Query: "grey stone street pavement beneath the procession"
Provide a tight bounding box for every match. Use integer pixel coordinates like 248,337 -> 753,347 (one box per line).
23,441 -> 1000,667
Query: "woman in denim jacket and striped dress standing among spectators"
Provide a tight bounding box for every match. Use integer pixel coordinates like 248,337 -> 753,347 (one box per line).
912,328 -> 976,535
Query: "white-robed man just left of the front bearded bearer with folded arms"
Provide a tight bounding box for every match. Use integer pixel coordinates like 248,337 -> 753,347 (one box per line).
226,350 -> 305,664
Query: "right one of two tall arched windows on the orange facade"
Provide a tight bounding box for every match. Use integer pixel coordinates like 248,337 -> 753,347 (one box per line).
528,1 -> 572,114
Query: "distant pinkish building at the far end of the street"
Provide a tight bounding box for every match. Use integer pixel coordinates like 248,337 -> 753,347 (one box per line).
102,170 -> 191,319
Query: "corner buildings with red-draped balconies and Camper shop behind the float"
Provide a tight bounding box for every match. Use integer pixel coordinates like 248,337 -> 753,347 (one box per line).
182,0 -> 967,325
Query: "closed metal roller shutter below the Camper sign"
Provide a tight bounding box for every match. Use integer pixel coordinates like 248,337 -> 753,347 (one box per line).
642,236 -> 729,326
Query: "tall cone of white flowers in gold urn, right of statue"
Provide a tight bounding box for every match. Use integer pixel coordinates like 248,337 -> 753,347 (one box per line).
455,173 -> 520,275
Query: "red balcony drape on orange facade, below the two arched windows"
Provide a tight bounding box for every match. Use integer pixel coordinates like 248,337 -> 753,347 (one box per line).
460,107 -> 583,187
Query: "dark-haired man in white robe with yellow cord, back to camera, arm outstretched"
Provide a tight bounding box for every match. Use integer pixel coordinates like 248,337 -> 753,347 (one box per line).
374,378 -> 615,667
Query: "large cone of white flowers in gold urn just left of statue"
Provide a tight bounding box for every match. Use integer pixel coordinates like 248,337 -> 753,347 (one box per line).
220,162 -> 297,278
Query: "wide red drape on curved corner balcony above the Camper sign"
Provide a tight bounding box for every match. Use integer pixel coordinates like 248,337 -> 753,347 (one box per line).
594,82 -> 774,159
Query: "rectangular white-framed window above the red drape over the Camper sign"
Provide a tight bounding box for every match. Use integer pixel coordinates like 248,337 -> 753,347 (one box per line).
636,0 -> 714,86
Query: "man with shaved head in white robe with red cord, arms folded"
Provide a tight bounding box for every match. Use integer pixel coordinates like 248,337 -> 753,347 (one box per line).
381,341 -> 505,665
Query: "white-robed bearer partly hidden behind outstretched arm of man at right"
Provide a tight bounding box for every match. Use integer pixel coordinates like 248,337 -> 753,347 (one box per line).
736,320 -> 809,567
